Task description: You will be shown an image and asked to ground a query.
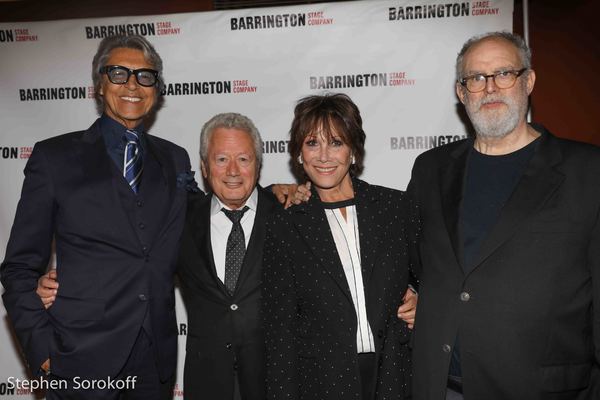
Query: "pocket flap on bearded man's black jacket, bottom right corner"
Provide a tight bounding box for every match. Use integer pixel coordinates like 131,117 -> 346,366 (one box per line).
541,362 -> 592,392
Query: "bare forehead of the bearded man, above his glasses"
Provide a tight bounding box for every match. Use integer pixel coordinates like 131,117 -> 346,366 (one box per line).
463,38 -> 522,74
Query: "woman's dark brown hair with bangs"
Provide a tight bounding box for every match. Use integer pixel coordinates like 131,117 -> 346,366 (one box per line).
289,93 -> 366,177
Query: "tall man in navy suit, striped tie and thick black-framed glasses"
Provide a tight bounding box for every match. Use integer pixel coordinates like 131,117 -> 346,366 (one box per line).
1,36 -> 193,400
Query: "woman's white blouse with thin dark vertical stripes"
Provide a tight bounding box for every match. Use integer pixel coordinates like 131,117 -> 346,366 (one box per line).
325,206 -> 375,353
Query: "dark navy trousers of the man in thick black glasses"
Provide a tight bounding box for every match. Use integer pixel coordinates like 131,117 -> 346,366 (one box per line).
46,329 -> 175,400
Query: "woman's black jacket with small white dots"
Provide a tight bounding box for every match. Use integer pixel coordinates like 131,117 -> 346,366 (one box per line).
263,180 -> 410,400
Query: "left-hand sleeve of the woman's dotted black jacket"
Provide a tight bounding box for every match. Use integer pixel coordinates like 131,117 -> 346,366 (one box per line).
262,215 -> 299,400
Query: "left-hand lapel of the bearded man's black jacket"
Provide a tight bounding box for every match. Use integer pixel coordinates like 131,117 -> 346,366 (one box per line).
439,140 -> 473,266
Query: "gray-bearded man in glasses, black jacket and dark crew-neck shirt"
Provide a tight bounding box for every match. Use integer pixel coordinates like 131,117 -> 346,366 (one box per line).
409,33 -> 600,400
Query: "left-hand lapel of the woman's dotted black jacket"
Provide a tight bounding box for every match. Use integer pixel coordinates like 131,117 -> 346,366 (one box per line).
293,188 -> 352,303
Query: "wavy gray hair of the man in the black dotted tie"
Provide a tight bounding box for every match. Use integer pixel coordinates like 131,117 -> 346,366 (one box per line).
200,113 -> 263,168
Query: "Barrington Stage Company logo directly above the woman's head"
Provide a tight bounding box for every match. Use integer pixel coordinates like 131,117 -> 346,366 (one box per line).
309,71 -> 416,90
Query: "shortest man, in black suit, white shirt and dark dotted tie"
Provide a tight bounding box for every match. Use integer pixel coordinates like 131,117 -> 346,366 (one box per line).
178,113 -> 279,400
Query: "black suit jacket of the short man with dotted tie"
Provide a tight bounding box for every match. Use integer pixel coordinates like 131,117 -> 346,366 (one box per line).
178,187 -> 279,400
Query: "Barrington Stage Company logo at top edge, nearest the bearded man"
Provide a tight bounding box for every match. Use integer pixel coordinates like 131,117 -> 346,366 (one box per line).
388,1 -> 500,21
